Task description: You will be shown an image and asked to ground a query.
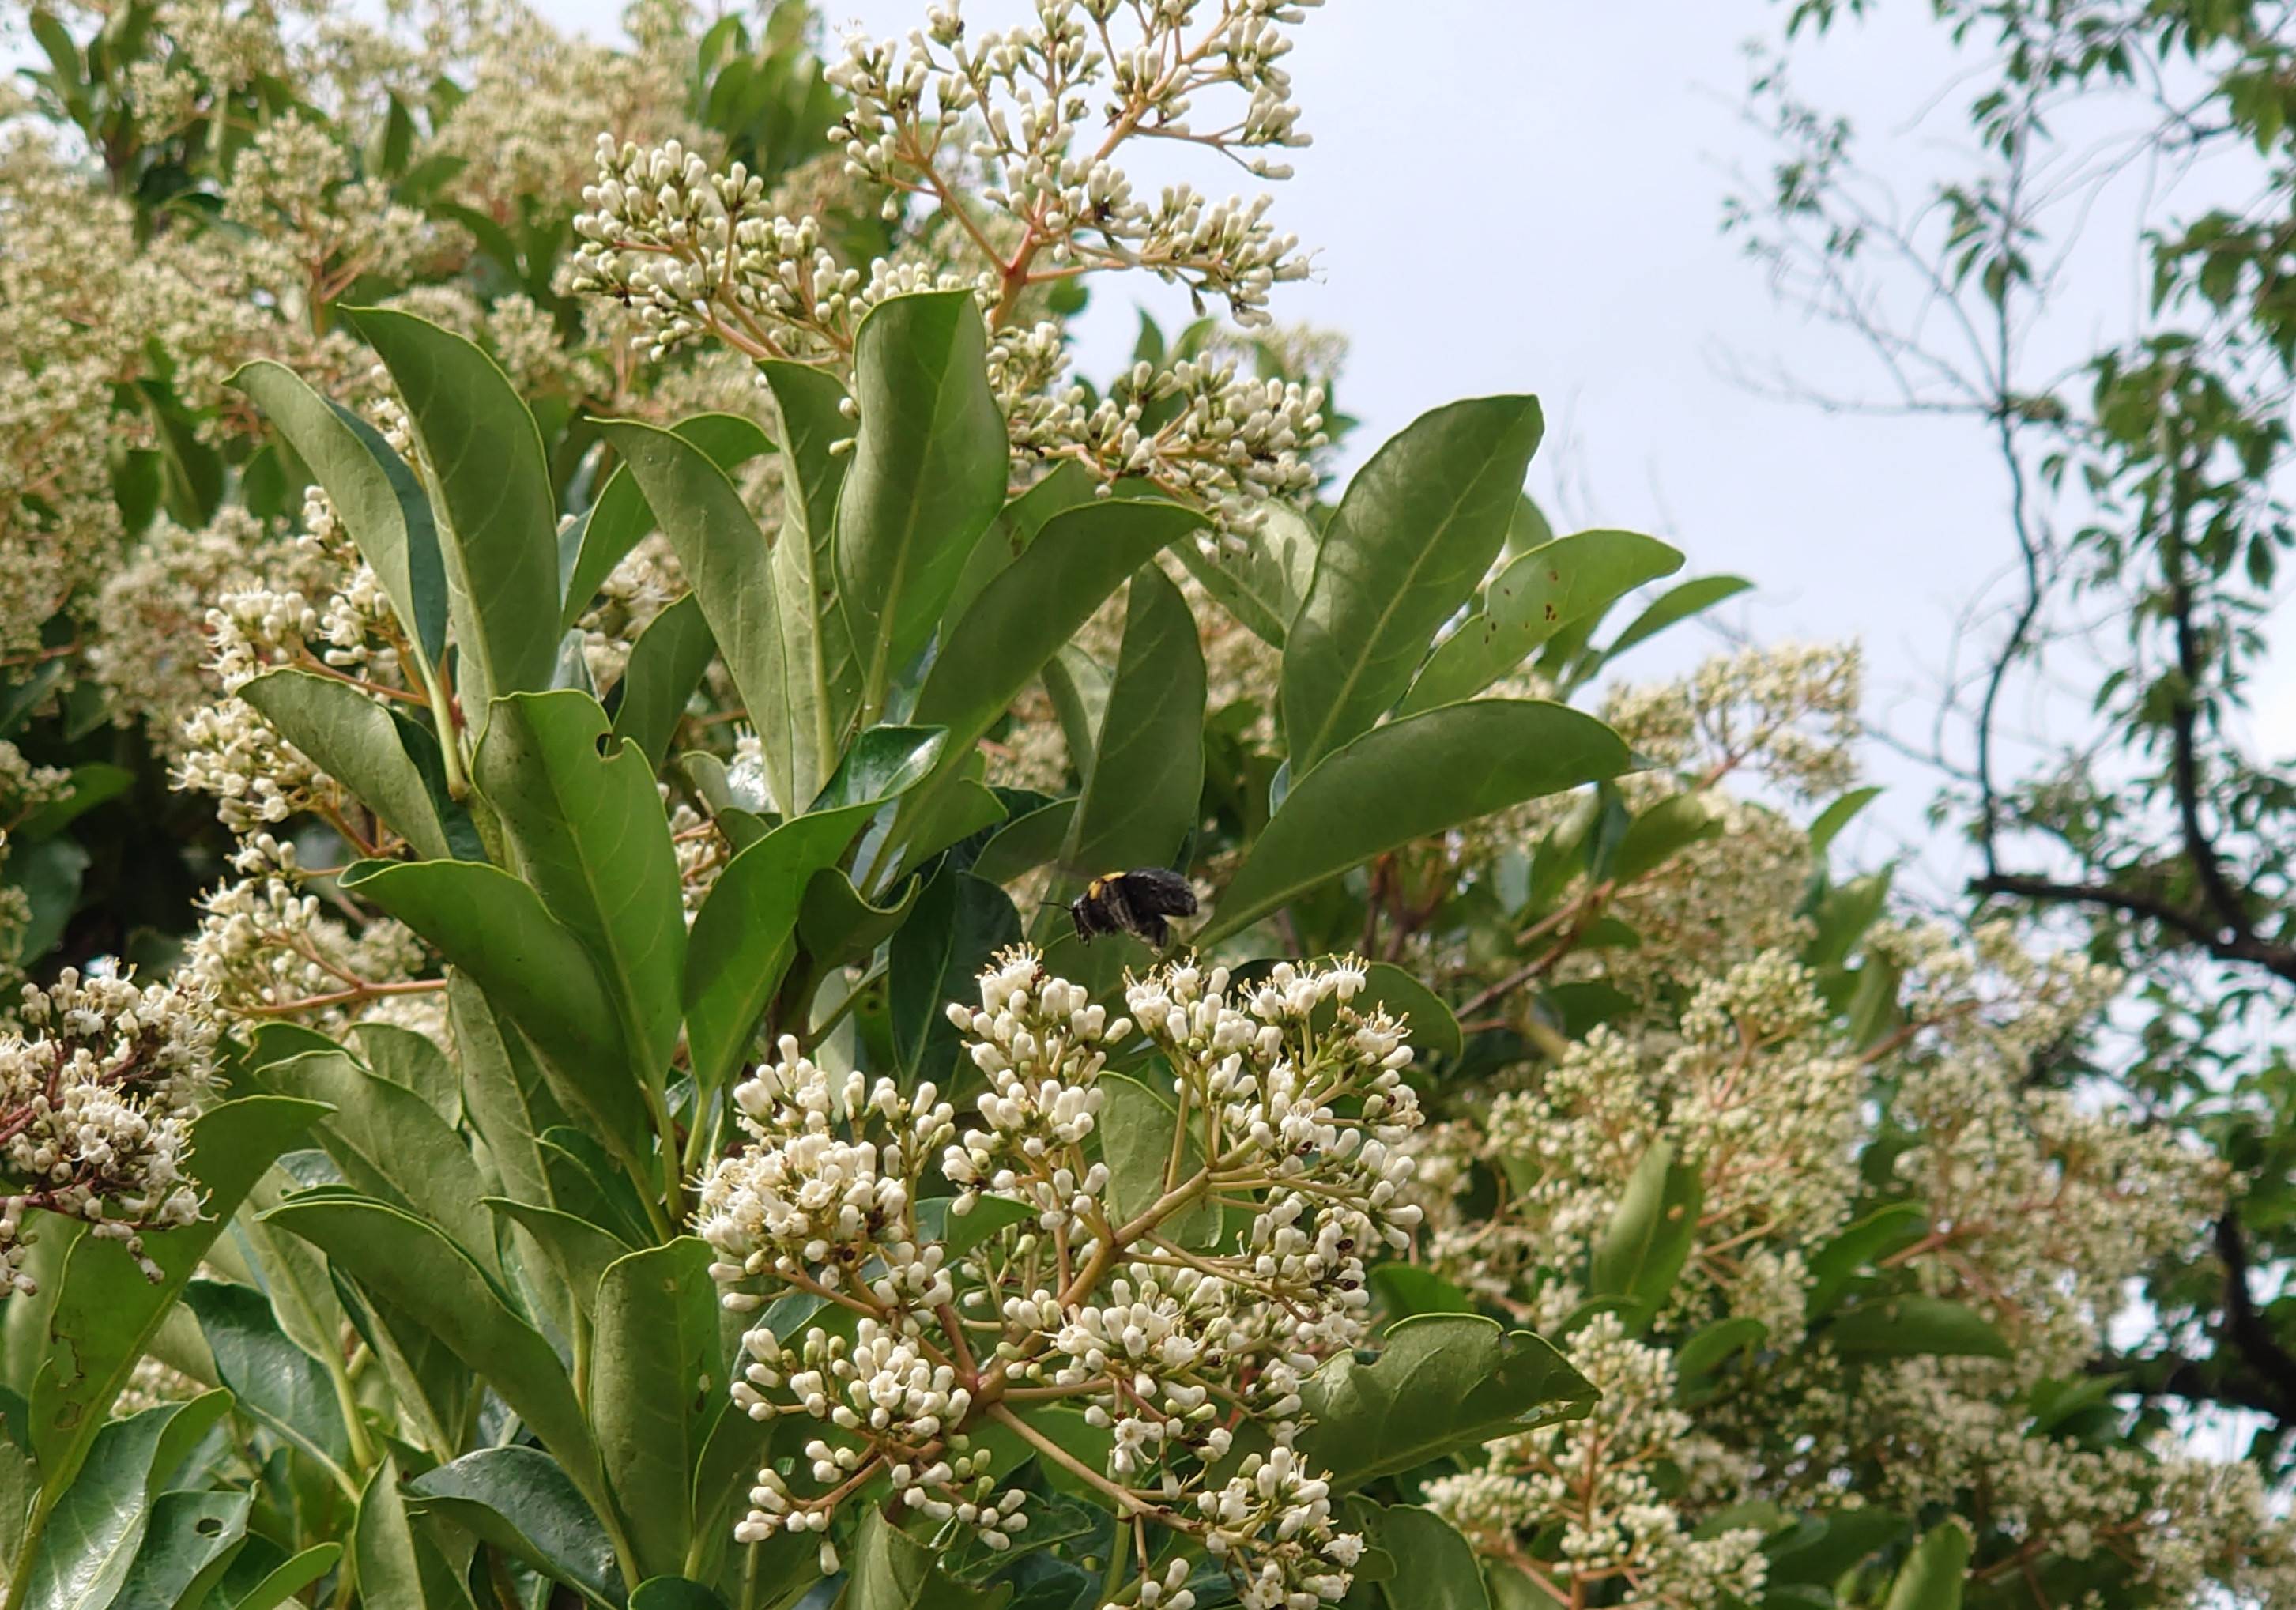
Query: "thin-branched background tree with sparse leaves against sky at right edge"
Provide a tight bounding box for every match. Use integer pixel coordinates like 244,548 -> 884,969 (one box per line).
1729,0 -> 2296,1470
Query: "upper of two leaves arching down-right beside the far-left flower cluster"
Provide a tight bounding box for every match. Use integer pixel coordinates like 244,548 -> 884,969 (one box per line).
262,1052 -> 503,1280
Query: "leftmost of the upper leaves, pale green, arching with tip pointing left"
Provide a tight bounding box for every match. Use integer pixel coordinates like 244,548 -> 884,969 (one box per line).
230,360 -> 447,666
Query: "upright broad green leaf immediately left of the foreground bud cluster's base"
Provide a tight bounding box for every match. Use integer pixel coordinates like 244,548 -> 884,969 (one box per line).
587,1235 -> 721,1575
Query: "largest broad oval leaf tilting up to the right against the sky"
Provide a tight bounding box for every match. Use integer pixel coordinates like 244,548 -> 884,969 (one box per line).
1284,398 -> 1543,776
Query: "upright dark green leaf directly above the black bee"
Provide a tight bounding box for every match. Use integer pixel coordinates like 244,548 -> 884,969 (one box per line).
1061,565 -> 1203,877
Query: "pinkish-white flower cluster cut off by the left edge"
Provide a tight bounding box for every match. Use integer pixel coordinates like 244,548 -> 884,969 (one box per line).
0,969 -> 216,1298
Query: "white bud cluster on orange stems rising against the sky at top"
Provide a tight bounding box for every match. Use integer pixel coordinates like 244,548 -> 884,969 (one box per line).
571,0 -> 1327,524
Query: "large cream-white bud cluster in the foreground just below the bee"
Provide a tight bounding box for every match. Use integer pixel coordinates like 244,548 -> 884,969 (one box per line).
698,946 -> 1419,1610
